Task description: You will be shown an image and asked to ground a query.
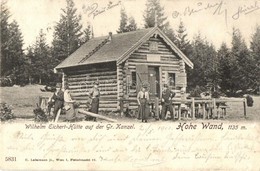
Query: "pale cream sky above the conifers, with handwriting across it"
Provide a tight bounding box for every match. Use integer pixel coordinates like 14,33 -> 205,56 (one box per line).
7,0 -> 260,48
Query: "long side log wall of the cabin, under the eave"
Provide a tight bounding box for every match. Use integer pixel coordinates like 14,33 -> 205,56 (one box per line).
63,63 -> 118,111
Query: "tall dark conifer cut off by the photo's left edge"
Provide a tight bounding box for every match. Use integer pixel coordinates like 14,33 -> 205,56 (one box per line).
0,1 -> 25,84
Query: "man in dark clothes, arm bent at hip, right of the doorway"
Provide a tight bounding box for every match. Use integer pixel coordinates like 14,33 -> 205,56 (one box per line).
162,84 -> 175,120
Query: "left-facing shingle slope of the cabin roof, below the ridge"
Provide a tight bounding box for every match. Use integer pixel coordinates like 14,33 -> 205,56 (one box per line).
56,28 -> 153,69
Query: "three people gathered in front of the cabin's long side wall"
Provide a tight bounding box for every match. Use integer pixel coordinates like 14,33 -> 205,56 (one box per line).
48,82 -> 100,121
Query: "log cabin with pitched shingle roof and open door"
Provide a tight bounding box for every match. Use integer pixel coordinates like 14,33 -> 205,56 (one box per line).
55,27 -> 193,111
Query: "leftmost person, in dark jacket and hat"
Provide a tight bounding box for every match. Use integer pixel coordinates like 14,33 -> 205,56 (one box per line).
51,83 -> 64,121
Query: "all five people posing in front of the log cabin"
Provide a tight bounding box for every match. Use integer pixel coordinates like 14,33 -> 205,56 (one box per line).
48,82 -> 178,122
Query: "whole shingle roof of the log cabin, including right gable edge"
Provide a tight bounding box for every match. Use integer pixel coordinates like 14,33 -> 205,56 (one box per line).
55,27 -> 193,69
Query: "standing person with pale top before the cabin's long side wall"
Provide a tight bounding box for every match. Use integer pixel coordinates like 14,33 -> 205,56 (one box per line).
86,82 -> 100,121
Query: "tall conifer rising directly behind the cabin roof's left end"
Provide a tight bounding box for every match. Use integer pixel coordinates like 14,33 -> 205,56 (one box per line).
52,0 -> 83,61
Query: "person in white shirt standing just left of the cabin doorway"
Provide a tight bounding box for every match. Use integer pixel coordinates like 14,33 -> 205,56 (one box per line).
137,85 -> 150,122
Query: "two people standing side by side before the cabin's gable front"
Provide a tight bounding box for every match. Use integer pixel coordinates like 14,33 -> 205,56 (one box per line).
137,84 -> 175,122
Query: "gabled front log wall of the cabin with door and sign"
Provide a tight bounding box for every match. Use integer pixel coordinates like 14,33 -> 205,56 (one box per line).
119,34 -> 187,108
